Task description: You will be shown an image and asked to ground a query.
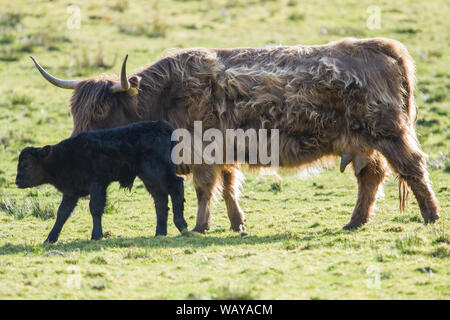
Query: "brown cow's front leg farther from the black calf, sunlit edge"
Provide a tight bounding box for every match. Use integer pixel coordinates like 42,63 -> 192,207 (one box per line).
222,166 -> 245,231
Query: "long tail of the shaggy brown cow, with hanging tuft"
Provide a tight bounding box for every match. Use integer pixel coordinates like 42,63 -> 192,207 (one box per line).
376,39 -> 417,212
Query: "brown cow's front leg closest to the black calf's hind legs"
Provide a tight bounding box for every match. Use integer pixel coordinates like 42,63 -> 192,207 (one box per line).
192,165 -> 220,233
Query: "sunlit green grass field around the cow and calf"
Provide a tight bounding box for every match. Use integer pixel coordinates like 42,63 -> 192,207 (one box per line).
0,0 -> 450,299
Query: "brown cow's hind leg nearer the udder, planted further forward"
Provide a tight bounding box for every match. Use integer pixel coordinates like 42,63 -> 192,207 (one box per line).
344,153 -> 387,230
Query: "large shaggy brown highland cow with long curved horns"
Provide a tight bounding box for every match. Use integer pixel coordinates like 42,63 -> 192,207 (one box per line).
33,38 -> 439,232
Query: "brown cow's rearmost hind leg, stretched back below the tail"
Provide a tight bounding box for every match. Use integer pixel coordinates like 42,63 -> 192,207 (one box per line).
376,129 -> 439,224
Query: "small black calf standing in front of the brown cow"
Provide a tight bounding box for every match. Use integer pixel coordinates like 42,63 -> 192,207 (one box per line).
16,121 -> 187,243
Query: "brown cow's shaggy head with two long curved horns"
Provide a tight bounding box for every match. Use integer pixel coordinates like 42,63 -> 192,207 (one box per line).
31,55 -> 141,135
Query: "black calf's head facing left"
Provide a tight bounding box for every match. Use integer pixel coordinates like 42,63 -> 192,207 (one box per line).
16,146 -> 52,189
